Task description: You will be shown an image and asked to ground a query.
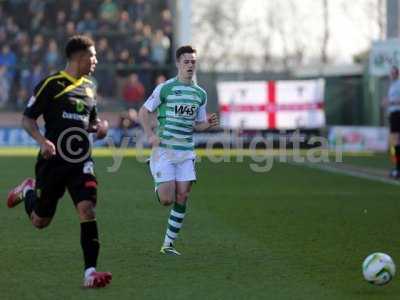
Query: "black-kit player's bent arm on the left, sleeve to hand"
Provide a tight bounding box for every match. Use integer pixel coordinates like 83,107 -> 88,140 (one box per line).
22,81 -> 56,159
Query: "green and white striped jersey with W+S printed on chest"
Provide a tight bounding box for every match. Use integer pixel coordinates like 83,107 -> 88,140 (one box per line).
144,77 -> 207,151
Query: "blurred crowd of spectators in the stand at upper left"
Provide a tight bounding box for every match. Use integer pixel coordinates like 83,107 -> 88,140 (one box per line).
0,0 -> 173,109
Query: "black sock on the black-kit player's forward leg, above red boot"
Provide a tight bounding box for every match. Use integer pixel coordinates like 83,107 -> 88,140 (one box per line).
81,220 -> 100,270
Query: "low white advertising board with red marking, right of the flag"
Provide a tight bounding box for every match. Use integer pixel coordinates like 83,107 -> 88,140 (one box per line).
328,126 -> 389,152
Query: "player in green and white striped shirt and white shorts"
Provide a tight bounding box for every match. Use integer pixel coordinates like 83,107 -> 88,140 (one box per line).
139,46 -> 218,255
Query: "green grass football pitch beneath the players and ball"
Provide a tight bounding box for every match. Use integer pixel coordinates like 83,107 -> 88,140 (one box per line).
0,156 -> 400,299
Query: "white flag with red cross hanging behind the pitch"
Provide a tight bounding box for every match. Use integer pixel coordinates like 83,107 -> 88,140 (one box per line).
217,79 -> 325,129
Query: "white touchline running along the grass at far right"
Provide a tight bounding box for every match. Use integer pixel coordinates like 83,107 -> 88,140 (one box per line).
291,163 -> 400,186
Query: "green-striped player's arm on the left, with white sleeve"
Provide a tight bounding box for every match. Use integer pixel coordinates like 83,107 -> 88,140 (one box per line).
139,85 -> 162,147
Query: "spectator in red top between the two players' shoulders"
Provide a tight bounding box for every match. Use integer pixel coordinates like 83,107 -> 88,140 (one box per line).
122,73 -> 145,110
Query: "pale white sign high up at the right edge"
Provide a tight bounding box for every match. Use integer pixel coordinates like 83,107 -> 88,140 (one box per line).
369,39 -> 400,76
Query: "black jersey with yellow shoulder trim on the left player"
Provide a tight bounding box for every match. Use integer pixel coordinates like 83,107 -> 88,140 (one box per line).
24,71 -> 97,162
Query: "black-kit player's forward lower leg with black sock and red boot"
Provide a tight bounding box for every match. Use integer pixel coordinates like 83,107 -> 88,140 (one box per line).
76,200 -> 112,288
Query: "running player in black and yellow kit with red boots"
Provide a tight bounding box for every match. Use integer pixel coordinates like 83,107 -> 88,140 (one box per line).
7,36 -> 111,288
